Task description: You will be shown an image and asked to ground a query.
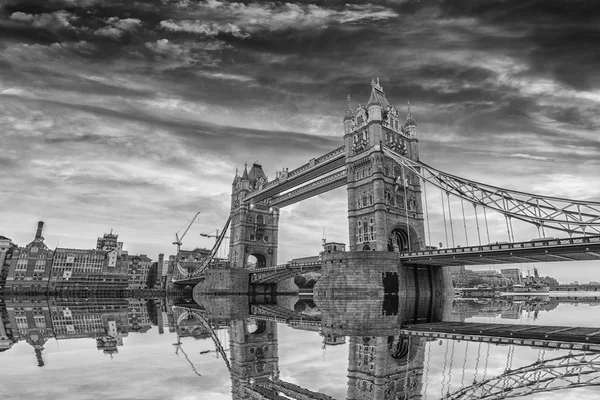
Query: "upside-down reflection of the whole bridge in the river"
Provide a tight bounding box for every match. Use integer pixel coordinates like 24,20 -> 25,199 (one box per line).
171,290 -> 600,400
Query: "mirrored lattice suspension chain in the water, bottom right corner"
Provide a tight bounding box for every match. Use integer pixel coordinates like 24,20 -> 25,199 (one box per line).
442,353 -> 600,400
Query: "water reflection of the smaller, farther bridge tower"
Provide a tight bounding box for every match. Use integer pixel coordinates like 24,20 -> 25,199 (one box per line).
229,320 -> 279,399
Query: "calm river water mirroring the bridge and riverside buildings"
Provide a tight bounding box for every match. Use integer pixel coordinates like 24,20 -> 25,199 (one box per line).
0,297 -> 600,400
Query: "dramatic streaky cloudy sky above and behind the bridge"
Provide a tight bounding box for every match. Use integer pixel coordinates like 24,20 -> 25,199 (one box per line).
0,0 -> 600,282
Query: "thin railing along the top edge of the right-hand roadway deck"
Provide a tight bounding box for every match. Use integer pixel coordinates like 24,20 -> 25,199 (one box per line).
400,236 -> 600,257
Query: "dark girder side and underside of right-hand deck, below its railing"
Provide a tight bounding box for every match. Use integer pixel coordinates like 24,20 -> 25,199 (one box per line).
400,243 -> 600,267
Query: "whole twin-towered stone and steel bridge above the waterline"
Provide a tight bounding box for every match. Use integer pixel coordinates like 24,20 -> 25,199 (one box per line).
182,76 -> 600,296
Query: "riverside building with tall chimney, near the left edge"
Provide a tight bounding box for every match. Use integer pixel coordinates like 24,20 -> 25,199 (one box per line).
5,221 -> 54,293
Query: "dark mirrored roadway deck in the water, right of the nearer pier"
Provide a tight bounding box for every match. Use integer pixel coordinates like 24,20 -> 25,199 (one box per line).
402,322 -> 600,350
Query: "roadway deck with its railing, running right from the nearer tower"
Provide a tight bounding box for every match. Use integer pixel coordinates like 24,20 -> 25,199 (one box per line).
400,236 -> 600,267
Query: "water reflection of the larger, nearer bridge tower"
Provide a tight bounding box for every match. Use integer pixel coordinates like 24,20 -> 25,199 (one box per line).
347,335 -> 425,400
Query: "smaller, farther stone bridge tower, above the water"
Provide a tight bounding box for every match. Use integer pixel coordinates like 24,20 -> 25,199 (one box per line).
229,162 -> 279,269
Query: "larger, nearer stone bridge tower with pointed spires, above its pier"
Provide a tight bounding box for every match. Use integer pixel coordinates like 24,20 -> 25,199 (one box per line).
344,78 -> 425,252
